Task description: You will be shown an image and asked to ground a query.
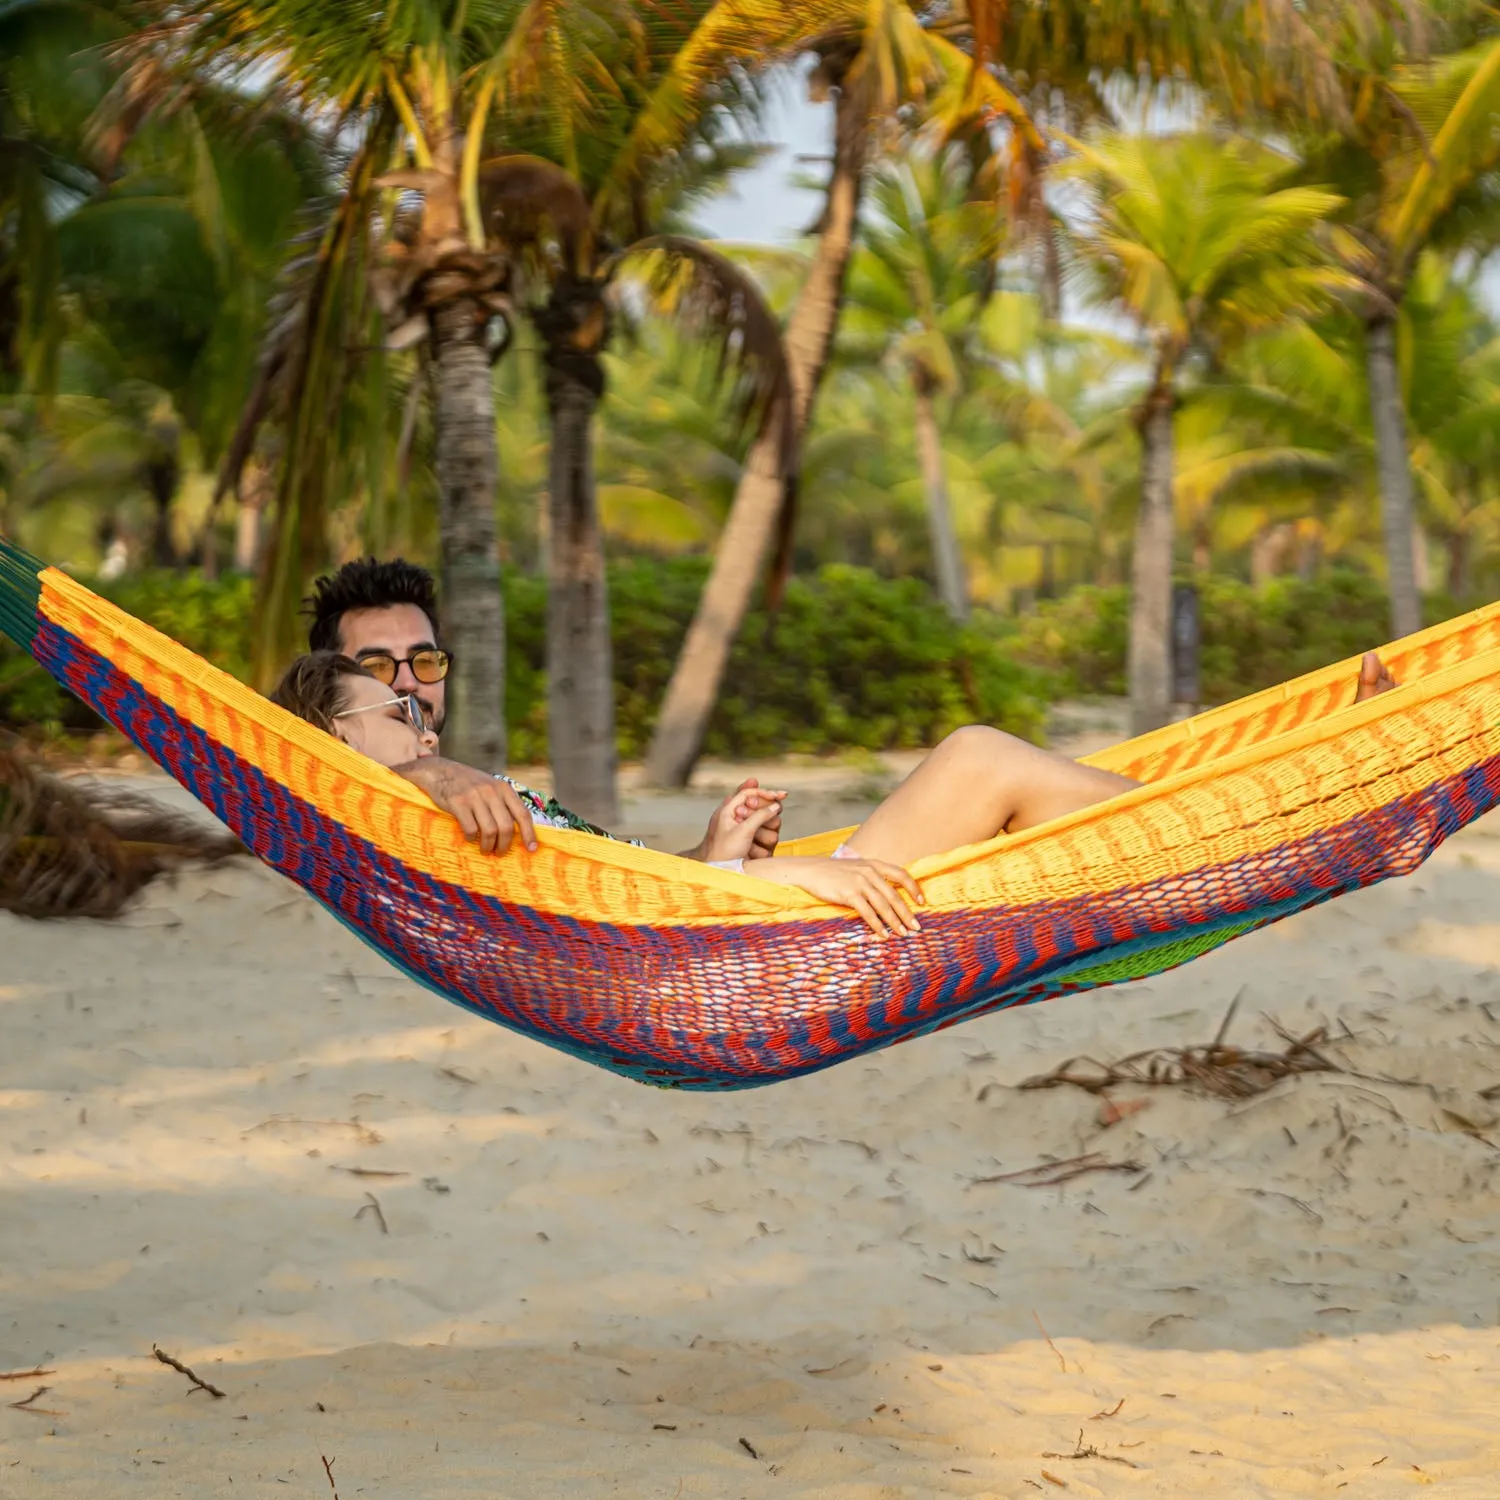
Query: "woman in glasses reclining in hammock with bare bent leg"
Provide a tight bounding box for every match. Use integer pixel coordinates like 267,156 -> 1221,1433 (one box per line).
272,651 -> 1397,938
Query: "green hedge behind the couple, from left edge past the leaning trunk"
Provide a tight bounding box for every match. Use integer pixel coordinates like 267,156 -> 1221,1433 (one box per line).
0,560 -> 1046,762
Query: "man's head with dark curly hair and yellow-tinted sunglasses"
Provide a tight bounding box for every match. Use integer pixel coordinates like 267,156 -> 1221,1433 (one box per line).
305,558 -> 449,734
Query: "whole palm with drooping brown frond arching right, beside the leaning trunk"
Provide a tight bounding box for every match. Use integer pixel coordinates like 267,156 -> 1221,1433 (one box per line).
482,112 -> 789,824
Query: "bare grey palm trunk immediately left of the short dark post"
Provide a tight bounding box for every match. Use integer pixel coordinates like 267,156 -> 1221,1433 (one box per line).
1130,381 -> 1176,735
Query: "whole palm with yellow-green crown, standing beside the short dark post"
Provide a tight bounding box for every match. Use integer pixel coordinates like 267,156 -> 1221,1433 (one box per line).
1074,135 -> 1358,734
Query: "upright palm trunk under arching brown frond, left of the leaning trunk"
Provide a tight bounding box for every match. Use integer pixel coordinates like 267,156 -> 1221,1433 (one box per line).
546,345 -> 620,825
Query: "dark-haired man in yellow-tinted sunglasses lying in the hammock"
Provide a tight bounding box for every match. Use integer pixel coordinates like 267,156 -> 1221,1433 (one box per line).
305,558 -> 786,860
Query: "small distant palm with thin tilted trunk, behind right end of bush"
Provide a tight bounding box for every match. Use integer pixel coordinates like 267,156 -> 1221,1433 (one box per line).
842,147 -> 1001,621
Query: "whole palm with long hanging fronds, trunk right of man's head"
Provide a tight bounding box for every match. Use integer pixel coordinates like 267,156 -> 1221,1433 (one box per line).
138,0 -> 627,765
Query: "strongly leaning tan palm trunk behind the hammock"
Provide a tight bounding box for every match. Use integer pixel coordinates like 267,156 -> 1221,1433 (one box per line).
645,76 -> 870,786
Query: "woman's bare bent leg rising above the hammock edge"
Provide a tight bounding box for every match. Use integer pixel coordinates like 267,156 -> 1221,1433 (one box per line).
848,725 -> 1139,866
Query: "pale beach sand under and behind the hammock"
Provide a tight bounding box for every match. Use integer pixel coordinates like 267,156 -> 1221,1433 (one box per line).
0,750 -> 1500,1500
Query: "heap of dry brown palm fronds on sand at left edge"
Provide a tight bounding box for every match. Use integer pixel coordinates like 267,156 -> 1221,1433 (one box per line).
0,747 -> 243,917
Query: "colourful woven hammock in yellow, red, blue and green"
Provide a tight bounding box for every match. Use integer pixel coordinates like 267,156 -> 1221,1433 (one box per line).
0,540 -> 1500,1089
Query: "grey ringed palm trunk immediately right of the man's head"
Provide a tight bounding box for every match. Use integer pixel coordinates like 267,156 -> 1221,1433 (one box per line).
432,297 -> 506,770
